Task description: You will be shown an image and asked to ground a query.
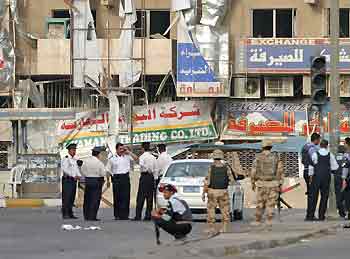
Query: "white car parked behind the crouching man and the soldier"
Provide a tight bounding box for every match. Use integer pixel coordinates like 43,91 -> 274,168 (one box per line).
157,159 -> 244,220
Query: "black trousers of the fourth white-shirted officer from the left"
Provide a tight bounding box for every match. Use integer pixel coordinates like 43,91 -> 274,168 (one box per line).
135,173 -> 154,219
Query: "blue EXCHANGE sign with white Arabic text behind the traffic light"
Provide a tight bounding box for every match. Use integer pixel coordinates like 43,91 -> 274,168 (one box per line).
236,38 -> 350,73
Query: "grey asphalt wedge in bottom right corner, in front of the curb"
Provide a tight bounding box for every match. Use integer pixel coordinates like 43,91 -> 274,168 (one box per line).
239,229 -> 350,259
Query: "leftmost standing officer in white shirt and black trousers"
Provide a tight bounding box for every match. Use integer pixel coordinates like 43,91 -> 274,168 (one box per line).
61,143 -> 81,219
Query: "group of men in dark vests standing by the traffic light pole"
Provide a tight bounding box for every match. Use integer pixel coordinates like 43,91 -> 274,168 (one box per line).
301,133 -> 350,221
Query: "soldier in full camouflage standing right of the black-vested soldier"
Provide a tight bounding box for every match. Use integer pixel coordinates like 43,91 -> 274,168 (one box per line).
251,141 -> 283,226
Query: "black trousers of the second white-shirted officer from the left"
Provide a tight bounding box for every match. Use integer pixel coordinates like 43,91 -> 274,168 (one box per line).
83,177 -> 104,220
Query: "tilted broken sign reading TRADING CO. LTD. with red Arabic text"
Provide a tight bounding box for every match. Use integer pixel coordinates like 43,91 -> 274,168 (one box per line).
56,101 -> 217,147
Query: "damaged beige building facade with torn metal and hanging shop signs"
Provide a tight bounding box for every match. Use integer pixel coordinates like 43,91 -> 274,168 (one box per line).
0,0 -> 350,182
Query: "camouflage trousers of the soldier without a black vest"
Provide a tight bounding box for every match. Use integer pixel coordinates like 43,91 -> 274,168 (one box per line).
255,187 -> 279,222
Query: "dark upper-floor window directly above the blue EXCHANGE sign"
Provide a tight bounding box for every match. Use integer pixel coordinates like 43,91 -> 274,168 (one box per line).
252,9 -> 296,38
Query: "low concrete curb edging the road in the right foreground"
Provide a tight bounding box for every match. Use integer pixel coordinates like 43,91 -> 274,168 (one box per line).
197,223 -> 341,257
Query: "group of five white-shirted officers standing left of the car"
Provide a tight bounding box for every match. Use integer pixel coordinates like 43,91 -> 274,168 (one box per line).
61,142 -> 172,221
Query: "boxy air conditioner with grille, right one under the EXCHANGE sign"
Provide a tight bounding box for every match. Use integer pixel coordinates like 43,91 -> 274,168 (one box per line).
265,77 -> 294,97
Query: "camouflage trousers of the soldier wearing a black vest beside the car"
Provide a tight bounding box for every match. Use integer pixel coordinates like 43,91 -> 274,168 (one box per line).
207,189 -> 230,232
